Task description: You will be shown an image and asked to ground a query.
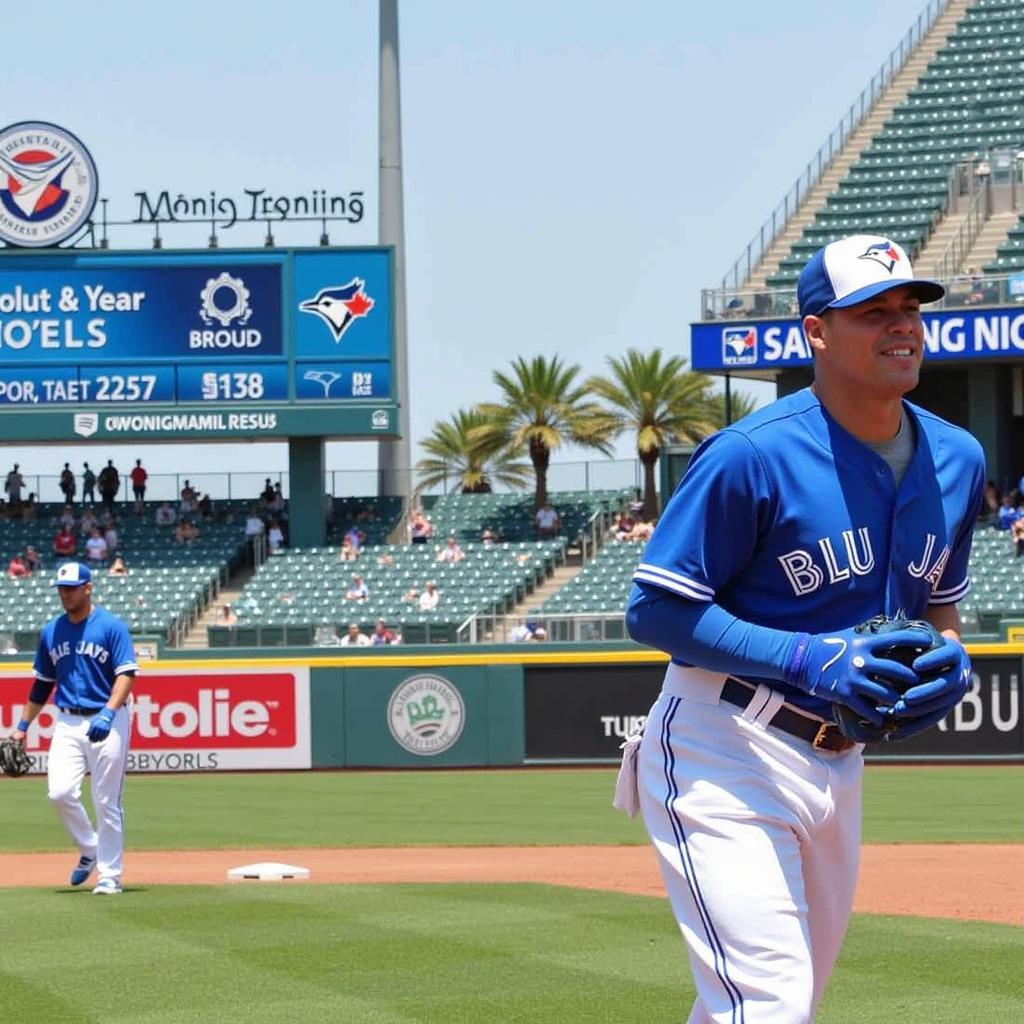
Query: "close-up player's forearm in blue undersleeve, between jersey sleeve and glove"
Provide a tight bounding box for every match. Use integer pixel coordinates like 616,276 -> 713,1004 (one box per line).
626,584 -> 801,680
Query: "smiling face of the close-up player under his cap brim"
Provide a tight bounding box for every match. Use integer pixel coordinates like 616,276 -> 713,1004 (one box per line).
805,288 -> 925,398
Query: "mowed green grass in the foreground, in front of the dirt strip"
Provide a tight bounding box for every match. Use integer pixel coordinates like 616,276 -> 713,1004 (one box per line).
0,884 -> 1024,1024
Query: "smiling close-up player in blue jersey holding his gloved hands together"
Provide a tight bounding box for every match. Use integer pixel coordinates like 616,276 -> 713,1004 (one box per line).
627,236 -> 985,1024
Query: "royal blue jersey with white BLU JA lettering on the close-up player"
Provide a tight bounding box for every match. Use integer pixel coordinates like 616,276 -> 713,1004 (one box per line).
634,389 -> 985,717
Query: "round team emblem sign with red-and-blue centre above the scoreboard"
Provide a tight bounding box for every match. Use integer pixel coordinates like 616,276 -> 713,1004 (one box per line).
0,121 -> 98,249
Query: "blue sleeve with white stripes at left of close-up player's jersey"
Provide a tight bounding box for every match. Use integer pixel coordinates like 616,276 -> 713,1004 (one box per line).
633,429 -> 772,601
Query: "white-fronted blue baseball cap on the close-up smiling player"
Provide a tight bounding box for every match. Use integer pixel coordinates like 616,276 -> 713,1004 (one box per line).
797,234 -> 946,316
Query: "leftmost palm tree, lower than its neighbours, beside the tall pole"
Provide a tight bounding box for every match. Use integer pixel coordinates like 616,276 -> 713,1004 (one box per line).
416,409 -> 529,495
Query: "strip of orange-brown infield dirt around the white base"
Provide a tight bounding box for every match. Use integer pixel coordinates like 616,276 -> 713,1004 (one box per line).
0,844 -> 1024,925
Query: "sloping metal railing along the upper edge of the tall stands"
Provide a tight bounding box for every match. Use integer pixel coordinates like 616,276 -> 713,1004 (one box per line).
722,0 -> 949,289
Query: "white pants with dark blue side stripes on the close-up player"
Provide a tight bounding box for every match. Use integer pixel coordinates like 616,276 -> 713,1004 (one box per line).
638,666 -> 863,1024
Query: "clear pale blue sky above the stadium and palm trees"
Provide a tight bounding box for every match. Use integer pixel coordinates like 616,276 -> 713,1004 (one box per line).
0,0 -> 909,491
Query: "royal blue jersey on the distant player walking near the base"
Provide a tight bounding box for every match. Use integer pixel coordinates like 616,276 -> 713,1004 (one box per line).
33,605 -> 138,710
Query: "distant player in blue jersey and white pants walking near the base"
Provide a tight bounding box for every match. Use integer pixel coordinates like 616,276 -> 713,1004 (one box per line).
13,562 -> 138,896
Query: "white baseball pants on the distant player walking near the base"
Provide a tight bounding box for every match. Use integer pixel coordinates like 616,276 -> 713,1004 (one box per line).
46,705 -> 131,882
